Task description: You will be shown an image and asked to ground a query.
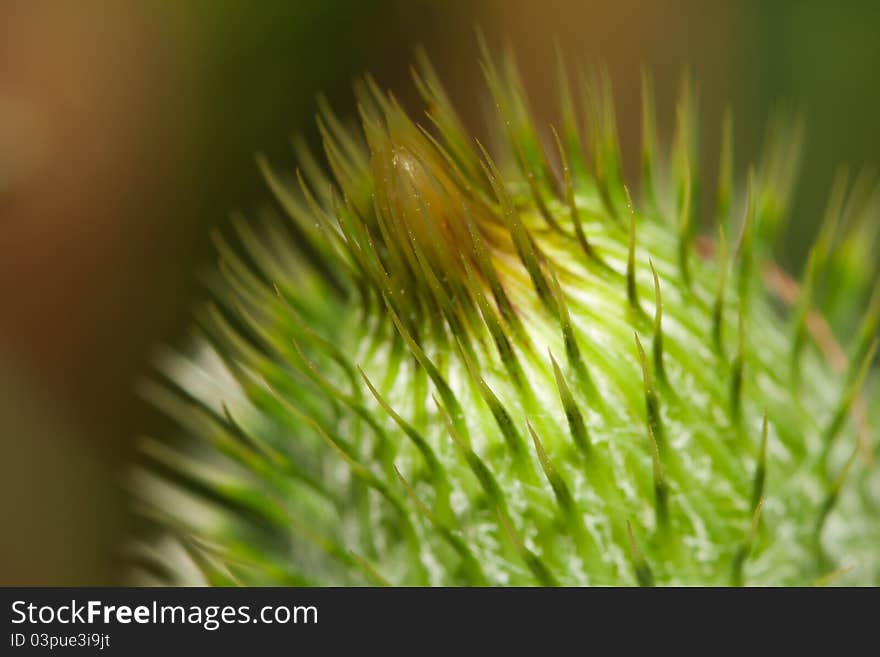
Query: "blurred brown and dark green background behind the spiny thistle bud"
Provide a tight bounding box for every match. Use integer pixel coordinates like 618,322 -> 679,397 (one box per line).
0,0 -> 880,585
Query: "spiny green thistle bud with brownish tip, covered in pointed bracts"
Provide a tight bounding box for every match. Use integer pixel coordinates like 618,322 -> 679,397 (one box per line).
130,44 -> 880,585
